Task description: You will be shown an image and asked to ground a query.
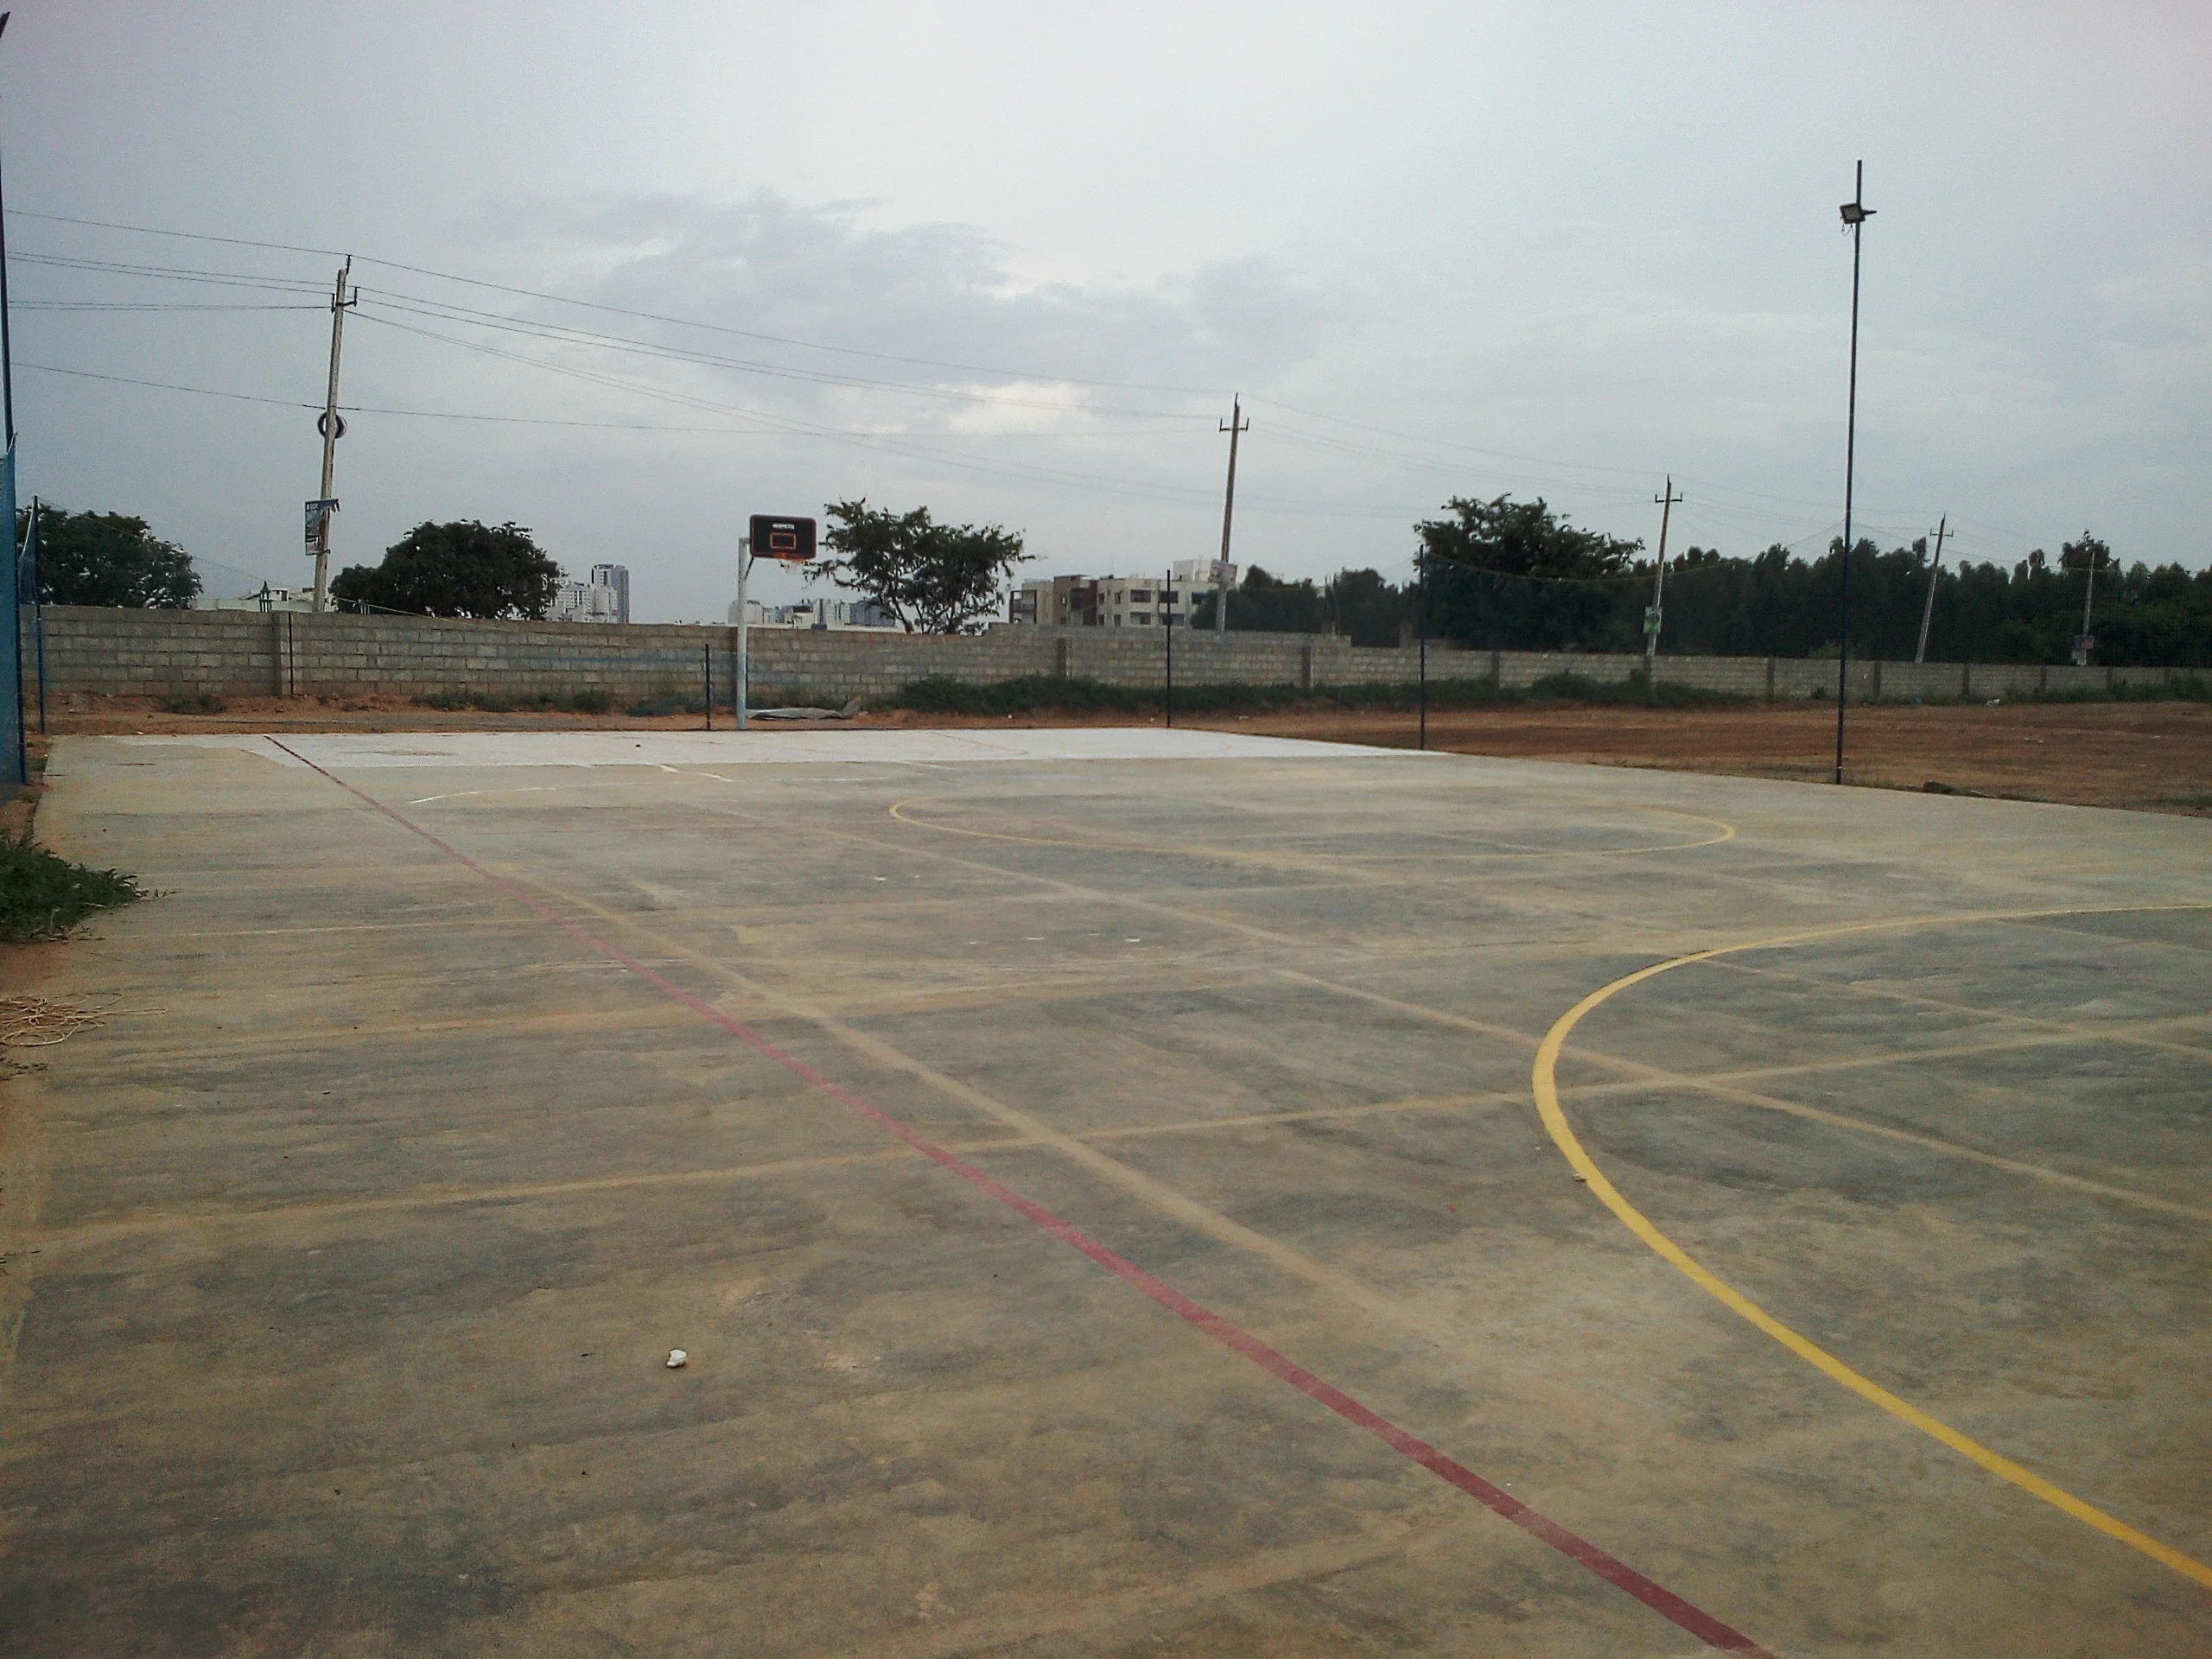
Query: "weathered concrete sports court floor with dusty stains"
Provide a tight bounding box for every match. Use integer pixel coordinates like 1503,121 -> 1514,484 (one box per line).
0,732 -> 2212,1659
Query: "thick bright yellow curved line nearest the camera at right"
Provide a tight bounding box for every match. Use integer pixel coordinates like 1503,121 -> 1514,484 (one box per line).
1529,905 -> 2212,1591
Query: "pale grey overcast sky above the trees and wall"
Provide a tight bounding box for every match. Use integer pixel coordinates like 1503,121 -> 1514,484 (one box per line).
0,0 -> 2212,620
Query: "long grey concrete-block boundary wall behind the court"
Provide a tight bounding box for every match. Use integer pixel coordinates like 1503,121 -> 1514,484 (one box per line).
22,606 -> 2196,703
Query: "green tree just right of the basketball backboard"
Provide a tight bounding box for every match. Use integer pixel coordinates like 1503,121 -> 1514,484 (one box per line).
807,500 -> 1022,632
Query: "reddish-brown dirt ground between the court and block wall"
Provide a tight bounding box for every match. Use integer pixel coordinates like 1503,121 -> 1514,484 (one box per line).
39,696 -> 2212,817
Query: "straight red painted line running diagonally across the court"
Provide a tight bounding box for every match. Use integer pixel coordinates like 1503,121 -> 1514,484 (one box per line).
268,736 -> 1774,1659
